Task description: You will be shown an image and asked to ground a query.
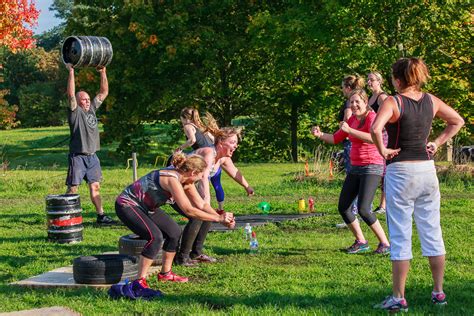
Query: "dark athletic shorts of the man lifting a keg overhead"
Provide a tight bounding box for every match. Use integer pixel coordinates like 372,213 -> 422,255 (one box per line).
66,154 -> 102,186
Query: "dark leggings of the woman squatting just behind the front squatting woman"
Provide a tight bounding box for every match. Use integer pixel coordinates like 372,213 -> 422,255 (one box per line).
171,203 -> 212,259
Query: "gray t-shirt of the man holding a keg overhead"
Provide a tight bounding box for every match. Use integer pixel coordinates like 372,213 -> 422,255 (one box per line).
68,97 -> 102,154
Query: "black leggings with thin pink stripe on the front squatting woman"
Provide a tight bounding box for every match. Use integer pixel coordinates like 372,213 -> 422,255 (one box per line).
115,202 -> 181,259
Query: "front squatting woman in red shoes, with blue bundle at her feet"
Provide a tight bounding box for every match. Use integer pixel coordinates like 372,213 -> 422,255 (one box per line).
113,154 -> 235,299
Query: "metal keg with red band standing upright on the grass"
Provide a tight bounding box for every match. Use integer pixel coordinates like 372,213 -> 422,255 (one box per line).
46,194 -> 84,243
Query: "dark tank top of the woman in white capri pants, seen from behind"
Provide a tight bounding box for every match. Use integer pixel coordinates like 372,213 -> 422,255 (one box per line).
385,93 -> 433,164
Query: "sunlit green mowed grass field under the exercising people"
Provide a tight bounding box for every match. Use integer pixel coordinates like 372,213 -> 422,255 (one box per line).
0,127 -> 474,315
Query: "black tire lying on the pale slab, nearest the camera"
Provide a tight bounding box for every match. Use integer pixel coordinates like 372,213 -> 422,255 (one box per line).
72,255 -> 138,284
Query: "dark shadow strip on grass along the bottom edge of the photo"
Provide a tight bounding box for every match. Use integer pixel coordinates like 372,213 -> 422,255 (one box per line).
0,281 -> 474,315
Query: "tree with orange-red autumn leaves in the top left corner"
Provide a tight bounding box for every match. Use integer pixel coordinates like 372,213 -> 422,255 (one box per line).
0,0 -> 39,50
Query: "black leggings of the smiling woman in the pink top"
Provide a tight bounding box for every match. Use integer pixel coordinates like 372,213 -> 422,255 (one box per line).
338,173 -> 381,226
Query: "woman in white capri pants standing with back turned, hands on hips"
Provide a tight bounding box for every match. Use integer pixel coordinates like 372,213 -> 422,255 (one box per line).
371,58 -> 464,311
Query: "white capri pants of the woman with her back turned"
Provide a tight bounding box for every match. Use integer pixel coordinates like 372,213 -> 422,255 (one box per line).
385,160 -> 446,260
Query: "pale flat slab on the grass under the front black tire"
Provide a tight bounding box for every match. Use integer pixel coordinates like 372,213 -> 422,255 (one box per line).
10,265 -> 161,289
